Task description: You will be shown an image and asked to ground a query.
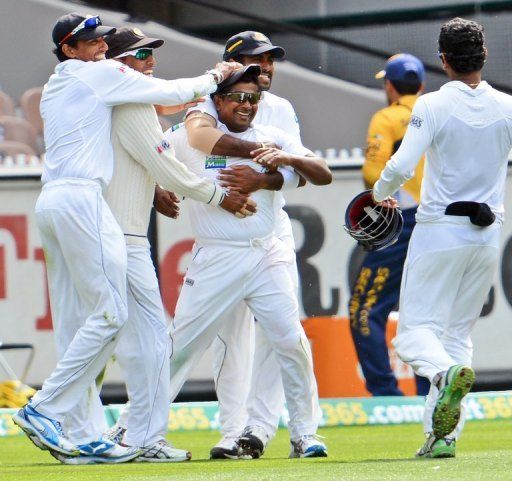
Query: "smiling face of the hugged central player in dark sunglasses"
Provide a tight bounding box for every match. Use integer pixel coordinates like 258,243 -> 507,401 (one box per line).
214,82 -> 260,132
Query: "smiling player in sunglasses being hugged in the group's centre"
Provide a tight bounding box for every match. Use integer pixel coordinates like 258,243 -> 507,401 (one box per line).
168,65 -> 332,457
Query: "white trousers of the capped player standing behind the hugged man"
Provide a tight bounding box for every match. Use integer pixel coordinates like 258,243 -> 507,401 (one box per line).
213,244 -> 305,439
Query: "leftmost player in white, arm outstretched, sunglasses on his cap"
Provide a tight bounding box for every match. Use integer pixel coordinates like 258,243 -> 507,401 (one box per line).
13,14 -> 241,462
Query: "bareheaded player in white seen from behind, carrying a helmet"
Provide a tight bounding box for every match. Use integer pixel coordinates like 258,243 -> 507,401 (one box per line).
373,18 -> 512,457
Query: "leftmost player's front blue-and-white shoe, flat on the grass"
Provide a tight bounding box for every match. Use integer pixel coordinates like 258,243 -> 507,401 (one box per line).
50,438 -> 142,465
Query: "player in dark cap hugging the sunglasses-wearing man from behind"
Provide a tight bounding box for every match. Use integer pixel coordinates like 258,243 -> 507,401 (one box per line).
180,31 -> 322,459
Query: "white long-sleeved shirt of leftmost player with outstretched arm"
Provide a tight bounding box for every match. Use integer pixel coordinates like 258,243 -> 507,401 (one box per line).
41,59 -> 217,186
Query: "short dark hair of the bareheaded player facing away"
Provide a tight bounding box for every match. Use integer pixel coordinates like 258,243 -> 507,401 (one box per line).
439,17 -> 485,73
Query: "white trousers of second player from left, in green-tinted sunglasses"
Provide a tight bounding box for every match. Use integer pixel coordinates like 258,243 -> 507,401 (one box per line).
115,245 -> 170,446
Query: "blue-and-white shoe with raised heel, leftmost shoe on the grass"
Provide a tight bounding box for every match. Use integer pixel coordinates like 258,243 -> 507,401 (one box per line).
12,404 -> 80,456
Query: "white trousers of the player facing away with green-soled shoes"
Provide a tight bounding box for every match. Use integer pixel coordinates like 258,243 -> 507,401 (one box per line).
393,216 -> 501,437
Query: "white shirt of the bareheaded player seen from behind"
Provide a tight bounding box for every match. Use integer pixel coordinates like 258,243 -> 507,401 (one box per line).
373,81 -> 512,222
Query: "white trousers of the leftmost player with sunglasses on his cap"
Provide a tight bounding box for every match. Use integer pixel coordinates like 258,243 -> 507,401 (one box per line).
32,179 -> 127,443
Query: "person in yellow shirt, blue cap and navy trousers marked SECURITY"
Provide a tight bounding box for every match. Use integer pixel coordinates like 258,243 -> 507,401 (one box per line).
349,53 -> 429,396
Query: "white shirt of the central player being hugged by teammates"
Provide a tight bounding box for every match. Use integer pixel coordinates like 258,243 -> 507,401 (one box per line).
166,122 -> 311,241
